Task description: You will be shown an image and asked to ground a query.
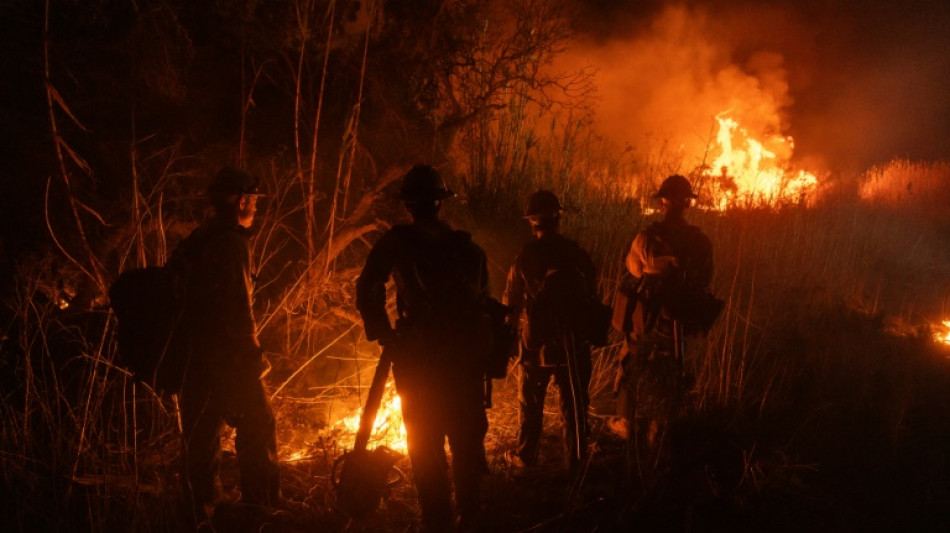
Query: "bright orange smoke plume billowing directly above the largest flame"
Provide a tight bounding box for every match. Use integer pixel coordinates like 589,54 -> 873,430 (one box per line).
564,7 -> 808,170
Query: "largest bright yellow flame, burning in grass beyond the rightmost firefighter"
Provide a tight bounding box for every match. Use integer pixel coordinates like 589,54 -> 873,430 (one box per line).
704,113 -> 818,210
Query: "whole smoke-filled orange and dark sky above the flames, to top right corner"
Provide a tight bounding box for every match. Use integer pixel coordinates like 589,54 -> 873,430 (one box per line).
564,0 -> 950,170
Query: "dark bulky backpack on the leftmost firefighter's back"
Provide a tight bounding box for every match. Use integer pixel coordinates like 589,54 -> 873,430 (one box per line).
109,257 -> 186,393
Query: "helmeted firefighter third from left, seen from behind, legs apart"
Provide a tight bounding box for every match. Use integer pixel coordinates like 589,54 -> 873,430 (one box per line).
502,190 -> 599,471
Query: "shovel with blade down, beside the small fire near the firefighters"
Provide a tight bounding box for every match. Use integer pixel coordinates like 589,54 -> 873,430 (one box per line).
330,348 -> 402,519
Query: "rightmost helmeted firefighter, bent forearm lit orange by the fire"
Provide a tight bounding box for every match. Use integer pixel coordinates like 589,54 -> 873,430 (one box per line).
608,174 -> 713,474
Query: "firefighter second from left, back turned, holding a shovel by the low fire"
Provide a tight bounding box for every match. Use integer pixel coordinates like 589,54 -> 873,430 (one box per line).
356,165 -> 491,531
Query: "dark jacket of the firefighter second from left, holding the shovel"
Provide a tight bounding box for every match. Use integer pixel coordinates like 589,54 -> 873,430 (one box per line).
356,221 -> 490,375
